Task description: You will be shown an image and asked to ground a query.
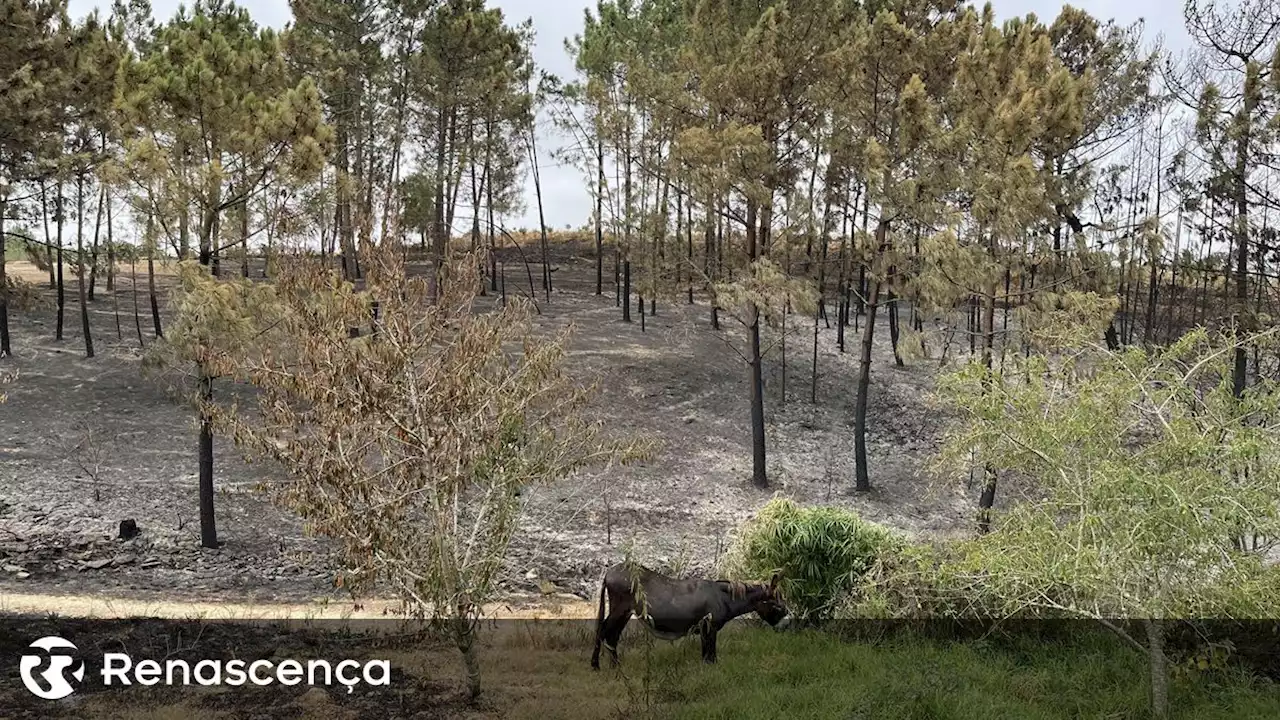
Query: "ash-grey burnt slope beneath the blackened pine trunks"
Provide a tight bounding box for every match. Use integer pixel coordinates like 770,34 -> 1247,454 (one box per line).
0,245 -> 977,602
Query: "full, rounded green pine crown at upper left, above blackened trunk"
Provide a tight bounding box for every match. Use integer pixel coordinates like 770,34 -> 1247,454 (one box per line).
114,0 -> 334,254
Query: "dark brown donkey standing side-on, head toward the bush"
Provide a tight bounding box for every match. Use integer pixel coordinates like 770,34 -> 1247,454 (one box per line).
591,564 -> 787,670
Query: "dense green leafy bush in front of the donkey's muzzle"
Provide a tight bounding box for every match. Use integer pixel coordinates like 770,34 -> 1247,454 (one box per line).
727,497 -> 906,620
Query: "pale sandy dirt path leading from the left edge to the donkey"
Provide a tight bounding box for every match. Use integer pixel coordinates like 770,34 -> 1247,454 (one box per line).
0,593 -> 596,620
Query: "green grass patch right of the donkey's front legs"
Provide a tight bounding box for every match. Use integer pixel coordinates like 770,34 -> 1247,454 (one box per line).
611,629 -> 1280,720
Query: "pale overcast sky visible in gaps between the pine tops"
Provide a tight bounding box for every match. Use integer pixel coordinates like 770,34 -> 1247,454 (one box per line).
70,0 -> 1188,228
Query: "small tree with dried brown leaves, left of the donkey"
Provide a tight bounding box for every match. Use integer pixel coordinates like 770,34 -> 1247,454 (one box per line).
154,242 -> 645,696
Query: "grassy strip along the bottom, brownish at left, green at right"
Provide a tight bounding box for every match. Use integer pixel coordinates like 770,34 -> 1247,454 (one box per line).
24,620 -> 1280,720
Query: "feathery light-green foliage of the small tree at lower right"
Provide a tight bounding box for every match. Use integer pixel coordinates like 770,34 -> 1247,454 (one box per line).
937,331 -> 1280,618
